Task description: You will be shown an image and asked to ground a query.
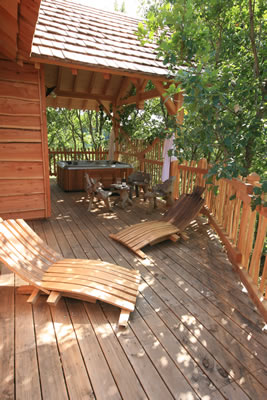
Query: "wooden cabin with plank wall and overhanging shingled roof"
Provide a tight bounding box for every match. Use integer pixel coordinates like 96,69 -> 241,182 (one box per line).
0,0 -> 183,219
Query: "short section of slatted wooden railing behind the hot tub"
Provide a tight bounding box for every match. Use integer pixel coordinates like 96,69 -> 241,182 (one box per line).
48,147 -> 108,176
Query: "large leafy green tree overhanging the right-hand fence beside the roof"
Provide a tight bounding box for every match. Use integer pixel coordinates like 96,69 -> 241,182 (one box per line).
139,0 -> 267,178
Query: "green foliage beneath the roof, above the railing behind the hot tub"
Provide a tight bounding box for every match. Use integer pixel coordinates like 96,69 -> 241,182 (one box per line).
47,107 -> 111,150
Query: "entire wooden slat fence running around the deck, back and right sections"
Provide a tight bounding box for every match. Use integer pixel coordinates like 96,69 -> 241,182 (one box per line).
49,143 -> 267,321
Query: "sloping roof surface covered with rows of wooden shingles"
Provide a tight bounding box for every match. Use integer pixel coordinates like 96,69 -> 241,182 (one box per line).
31,0 -> 168,78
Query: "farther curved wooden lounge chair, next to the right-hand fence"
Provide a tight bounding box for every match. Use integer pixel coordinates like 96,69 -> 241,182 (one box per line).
109,186 -> 205,258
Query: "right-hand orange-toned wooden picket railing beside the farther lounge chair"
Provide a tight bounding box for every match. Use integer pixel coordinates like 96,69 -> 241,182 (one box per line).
171,160 -> 267,322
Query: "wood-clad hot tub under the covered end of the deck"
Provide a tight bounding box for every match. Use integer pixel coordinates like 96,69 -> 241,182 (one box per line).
57,160 -> 133,192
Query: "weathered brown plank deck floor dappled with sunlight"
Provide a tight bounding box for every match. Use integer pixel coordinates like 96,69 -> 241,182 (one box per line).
0,182 -> 267,400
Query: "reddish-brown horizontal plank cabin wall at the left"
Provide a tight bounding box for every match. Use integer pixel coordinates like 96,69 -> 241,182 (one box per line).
0,60 -> 51,219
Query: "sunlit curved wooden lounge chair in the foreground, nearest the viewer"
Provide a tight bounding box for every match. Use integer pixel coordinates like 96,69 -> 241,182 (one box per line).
0,218 -> 140,326
